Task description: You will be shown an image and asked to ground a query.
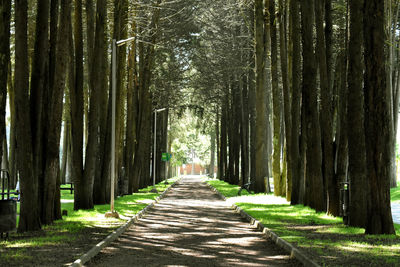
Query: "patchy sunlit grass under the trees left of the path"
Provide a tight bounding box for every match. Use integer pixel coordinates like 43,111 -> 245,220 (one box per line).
0,178 -> 177,265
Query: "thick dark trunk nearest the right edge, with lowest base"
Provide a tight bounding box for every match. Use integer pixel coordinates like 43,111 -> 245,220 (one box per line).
364,0 -> 395,234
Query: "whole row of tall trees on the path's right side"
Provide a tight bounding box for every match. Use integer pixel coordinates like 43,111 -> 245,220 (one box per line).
193,0 -> 399,234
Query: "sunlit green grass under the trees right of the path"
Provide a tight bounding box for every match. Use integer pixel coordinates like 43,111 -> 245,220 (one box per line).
207,180 -> 400,266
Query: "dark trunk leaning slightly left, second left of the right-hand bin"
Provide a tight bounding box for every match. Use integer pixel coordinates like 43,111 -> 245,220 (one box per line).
301,0 -> 326,214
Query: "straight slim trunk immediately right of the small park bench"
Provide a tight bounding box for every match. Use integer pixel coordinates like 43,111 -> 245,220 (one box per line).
254,0 -> 268,193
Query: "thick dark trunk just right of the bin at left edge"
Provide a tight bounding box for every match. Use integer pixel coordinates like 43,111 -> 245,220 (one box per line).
14,0 -> 41,232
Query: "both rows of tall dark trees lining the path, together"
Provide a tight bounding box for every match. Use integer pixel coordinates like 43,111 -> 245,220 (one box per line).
0,0 -> 400,236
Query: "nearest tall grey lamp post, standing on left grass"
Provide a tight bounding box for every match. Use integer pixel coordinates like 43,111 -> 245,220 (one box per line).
105,37 -> 135,218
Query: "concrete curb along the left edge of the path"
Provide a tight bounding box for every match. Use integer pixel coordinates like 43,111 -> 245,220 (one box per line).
69,179 -> 180,267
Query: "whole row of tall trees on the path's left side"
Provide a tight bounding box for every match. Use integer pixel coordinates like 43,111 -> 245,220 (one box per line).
0,0 -> 196,232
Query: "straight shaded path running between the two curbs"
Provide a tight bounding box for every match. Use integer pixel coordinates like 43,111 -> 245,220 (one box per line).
87,177 -> 301,266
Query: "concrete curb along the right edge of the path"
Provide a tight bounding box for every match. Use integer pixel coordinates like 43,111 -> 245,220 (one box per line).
206,182 -> 320,267
